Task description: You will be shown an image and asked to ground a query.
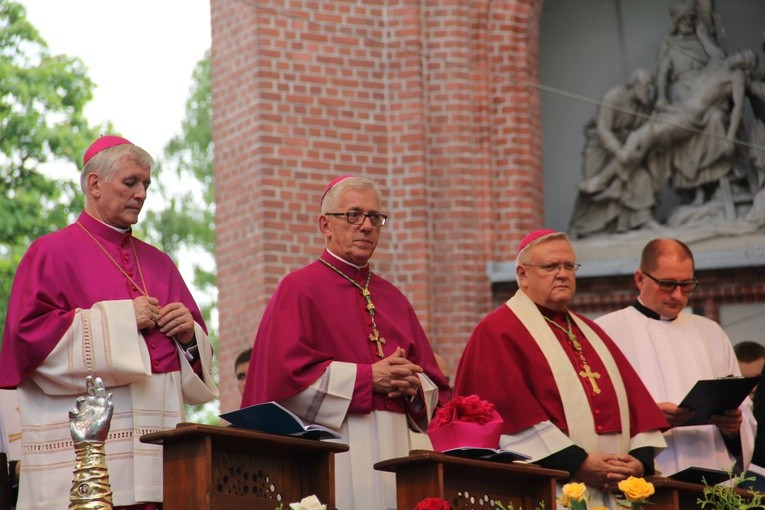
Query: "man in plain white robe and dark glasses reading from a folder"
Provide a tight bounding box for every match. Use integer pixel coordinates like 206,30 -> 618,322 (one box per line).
596,239 -> 756,476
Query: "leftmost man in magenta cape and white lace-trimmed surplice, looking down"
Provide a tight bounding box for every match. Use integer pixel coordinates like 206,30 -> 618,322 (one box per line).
0,136 -> 217,510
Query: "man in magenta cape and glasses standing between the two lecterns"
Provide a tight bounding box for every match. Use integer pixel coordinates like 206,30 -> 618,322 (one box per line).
242,176 -> 450,510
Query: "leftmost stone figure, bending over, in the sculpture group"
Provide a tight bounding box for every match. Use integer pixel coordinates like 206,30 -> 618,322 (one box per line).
569,69 -> 664,237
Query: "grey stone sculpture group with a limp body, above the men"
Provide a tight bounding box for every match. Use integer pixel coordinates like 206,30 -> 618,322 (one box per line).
569,0 -> 765,238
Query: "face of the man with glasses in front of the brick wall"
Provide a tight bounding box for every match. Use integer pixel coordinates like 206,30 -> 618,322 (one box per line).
319,189 -> 382,266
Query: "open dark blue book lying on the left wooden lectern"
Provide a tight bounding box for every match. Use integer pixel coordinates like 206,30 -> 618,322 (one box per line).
220,402 -> 342,439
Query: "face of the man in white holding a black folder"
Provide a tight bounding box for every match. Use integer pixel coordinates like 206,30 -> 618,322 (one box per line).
635,253 -> 693,319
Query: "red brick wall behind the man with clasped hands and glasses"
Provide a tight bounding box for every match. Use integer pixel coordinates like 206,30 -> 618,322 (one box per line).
211,0 -> 543,411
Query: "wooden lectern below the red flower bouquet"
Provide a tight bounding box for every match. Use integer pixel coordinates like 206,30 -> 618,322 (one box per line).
375,450 -> 569,510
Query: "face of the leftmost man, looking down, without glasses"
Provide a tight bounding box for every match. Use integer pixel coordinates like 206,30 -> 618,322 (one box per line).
85,159 -> 151,228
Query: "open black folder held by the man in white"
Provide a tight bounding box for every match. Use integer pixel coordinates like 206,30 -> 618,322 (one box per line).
678,376 -> 760,426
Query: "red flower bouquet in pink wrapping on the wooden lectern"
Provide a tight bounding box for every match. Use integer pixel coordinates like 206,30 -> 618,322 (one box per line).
428,395 -> 502,452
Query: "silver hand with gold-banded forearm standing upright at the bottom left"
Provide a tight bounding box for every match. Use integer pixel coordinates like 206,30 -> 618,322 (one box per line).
69,376 -> 114,510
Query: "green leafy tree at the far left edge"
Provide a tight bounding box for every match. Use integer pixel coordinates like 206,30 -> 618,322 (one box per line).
0,0 -> 98,327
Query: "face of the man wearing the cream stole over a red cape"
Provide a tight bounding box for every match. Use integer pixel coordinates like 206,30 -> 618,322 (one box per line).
517,239 -> 576,311
